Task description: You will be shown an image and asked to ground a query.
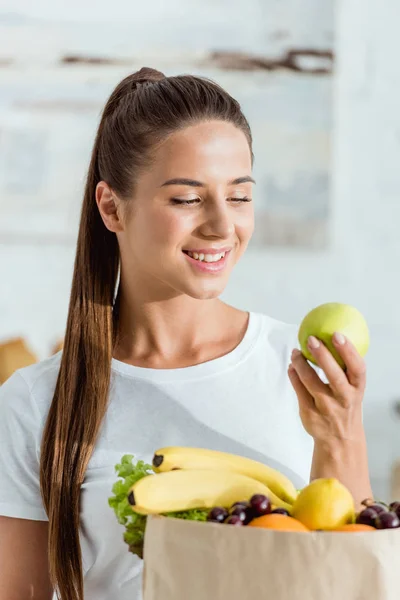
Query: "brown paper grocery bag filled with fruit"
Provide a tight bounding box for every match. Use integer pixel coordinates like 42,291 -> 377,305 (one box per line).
143,516 -> 400,600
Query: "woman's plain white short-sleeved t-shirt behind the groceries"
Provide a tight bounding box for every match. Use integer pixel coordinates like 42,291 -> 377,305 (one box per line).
0,313 -> 313,600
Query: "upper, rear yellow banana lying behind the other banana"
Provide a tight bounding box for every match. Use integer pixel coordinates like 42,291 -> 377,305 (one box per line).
153,446 -> 298,504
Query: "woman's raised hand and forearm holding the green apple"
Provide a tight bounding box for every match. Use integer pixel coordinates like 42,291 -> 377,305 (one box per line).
289,333 -> 372,503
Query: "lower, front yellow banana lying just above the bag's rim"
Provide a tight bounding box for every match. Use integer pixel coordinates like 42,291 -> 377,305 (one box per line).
128,469 -> 291,515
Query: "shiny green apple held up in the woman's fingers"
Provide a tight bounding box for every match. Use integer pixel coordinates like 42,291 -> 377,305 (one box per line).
298,302 -> 369,369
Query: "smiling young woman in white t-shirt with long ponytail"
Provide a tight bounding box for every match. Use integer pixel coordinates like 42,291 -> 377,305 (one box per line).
0,68 -> 371,600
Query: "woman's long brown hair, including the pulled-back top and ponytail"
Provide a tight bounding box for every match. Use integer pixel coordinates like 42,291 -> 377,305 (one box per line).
40,68 -> 252,600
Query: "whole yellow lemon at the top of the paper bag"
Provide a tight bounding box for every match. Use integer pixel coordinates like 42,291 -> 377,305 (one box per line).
291,478 -> 355,529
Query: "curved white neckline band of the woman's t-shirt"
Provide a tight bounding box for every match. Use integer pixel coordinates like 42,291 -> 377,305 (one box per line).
111,312 -> 261,381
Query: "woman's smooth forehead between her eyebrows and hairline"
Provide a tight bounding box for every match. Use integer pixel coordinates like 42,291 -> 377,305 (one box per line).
147,121 -> 251,185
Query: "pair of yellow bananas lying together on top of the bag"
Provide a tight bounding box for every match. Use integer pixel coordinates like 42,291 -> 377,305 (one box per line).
128,447 -> 298,515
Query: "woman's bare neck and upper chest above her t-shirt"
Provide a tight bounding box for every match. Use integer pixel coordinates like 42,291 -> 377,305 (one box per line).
114,278 -> 248,368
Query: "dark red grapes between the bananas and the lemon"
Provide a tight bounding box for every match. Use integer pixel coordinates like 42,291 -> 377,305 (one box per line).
207,494 -> 289,526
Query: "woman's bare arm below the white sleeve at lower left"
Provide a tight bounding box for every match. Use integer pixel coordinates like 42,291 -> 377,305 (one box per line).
0,517 -> 53,600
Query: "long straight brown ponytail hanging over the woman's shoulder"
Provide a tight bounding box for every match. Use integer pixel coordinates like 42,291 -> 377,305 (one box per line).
40,142 -> 119,600
